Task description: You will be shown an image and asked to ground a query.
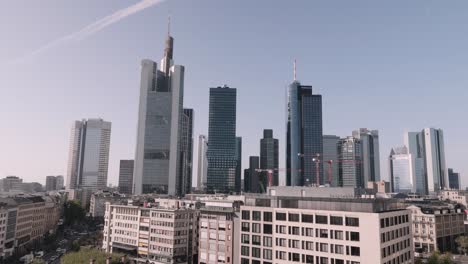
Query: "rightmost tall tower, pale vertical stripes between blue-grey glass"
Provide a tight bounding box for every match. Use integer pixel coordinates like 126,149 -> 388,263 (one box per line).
405,128 -> 449,194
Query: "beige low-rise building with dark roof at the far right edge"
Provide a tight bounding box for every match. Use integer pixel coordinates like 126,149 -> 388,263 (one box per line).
408,203 -> 465,256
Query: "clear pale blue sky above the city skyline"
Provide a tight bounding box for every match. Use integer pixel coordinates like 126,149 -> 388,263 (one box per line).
0,0 -> 468,186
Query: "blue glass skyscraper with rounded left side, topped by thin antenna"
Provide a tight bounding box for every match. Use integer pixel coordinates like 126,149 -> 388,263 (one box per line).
286,80 -> 323,186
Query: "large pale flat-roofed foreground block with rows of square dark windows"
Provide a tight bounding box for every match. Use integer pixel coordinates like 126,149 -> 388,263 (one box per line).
239,197 -> 414,264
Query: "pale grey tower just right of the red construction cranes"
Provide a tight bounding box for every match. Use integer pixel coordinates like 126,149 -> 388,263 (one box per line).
353,128 -> 380,185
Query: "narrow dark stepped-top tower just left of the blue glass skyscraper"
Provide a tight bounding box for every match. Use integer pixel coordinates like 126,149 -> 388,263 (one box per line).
260,129 -> 279,186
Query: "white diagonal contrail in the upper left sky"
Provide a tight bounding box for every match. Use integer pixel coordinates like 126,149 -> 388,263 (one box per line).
10,0 -> 166,64
